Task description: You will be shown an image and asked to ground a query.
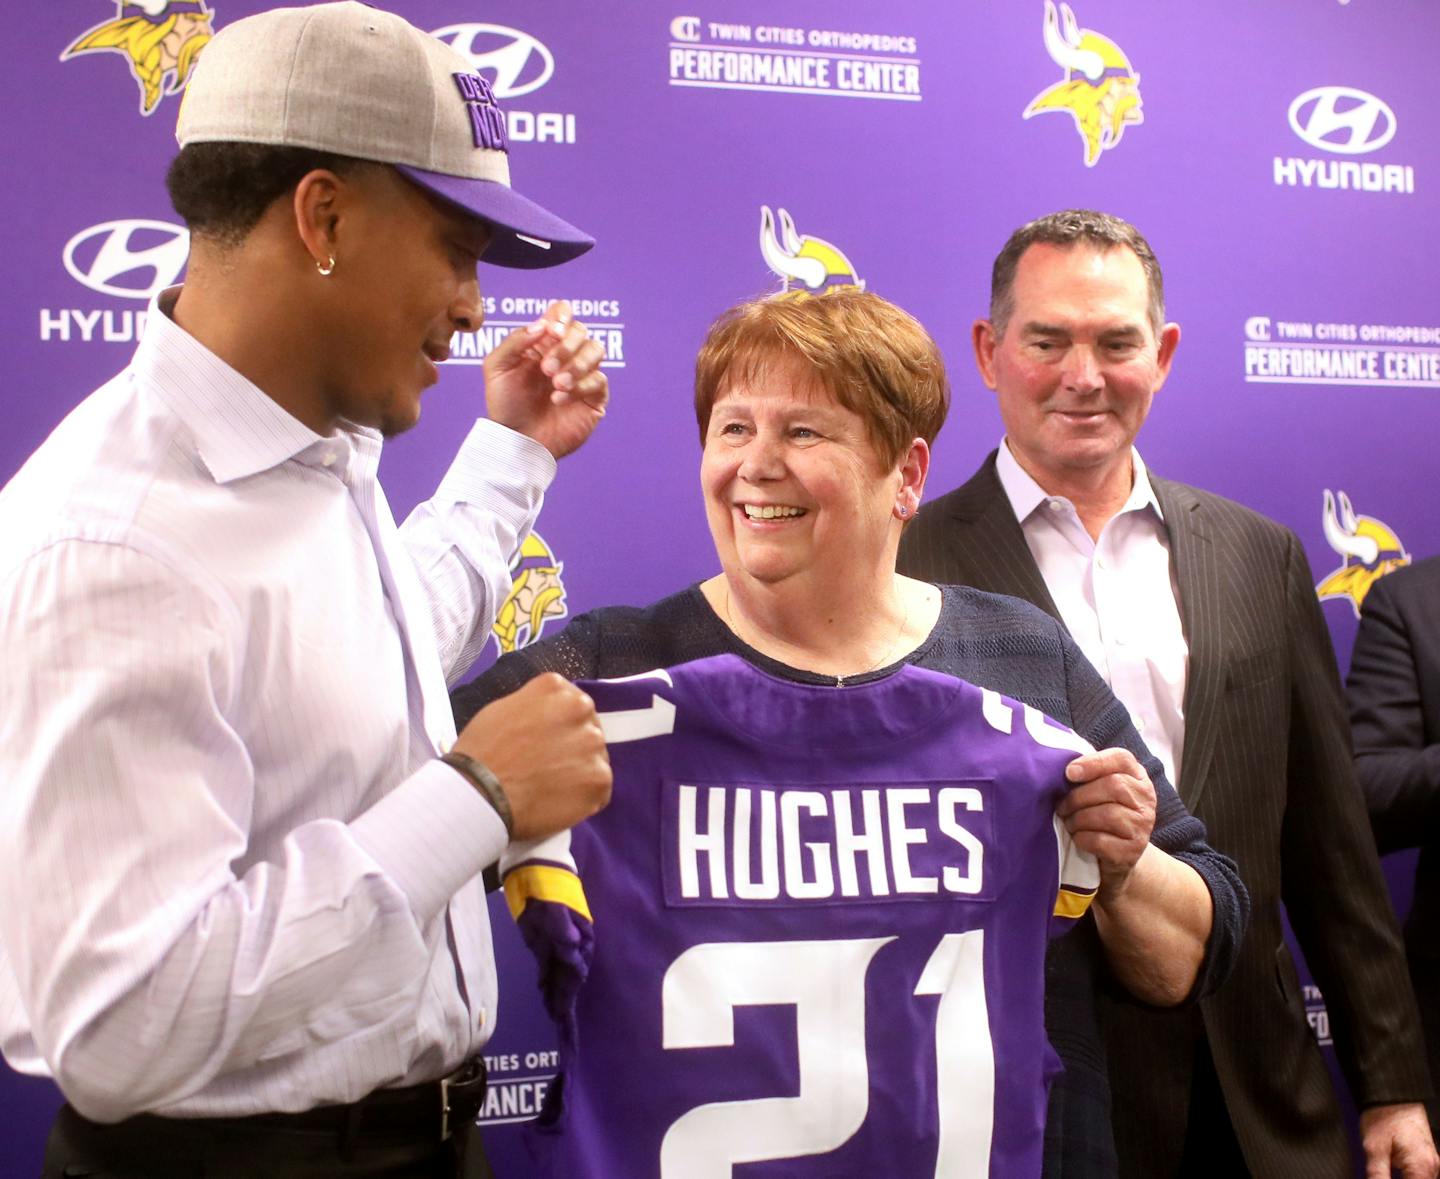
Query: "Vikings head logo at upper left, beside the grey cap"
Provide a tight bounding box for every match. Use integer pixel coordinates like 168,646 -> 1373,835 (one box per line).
60,0 -> 215,115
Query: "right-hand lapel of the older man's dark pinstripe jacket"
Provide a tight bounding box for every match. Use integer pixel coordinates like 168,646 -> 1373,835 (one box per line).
1151,475 -> 1225,813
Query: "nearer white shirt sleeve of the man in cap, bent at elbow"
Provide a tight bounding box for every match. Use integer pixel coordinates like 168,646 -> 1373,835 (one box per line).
0,538 -> 520,1121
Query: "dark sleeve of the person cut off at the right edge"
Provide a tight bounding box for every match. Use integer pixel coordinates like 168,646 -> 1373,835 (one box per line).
1345,567 -> 1440,852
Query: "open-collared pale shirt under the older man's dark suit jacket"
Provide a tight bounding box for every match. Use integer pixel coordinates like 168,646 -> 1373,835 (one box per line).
995,443 -> 1189,785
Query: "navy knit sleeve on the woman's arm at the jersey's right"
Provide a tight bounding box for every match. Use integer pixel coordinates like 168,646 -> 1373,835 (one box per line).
1061,621 -> 1250,1002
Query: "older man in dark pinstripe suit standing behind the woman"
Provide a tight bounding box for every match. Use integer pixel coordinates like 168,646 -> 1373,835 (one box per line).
900,210 -> 1440,1179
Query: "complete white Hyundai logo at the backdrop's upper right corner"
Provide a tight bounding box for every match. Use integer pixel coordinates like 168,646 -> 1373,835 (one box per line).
1274,86 -> 1416,193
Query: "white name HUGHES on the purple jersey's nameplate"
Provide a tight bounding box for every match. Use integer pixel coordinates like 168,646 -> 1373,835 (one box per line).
661,780 -> 994,905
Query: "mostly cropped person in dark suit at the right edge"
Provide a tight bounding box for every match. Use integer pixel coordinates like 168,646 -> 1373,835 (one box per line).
1345,557 -> 1440,1130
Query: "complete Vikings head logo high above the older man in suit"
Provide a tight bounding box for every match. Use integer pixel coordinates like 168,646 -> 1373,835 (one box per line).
1024,0 -> 1145,168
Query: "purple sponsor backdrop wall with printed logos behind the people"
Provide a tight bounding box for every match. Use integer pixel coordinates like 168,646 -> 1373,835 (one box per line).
0,0 -> 1440,1175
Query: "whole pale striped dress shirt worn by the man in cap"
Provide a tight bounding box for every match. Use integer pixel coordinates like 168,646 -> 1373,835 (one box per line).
0,291 -> 554,1121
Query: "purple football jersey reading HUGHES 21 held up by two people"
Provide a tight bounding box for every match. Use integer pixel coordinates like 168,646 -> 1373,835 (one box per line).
503,655 -> 1099,1179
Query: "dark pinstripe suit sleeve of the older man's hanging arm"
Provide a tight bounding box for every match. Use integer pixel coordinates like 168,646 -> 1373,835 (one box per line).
1280,536 -> 1430,1108
